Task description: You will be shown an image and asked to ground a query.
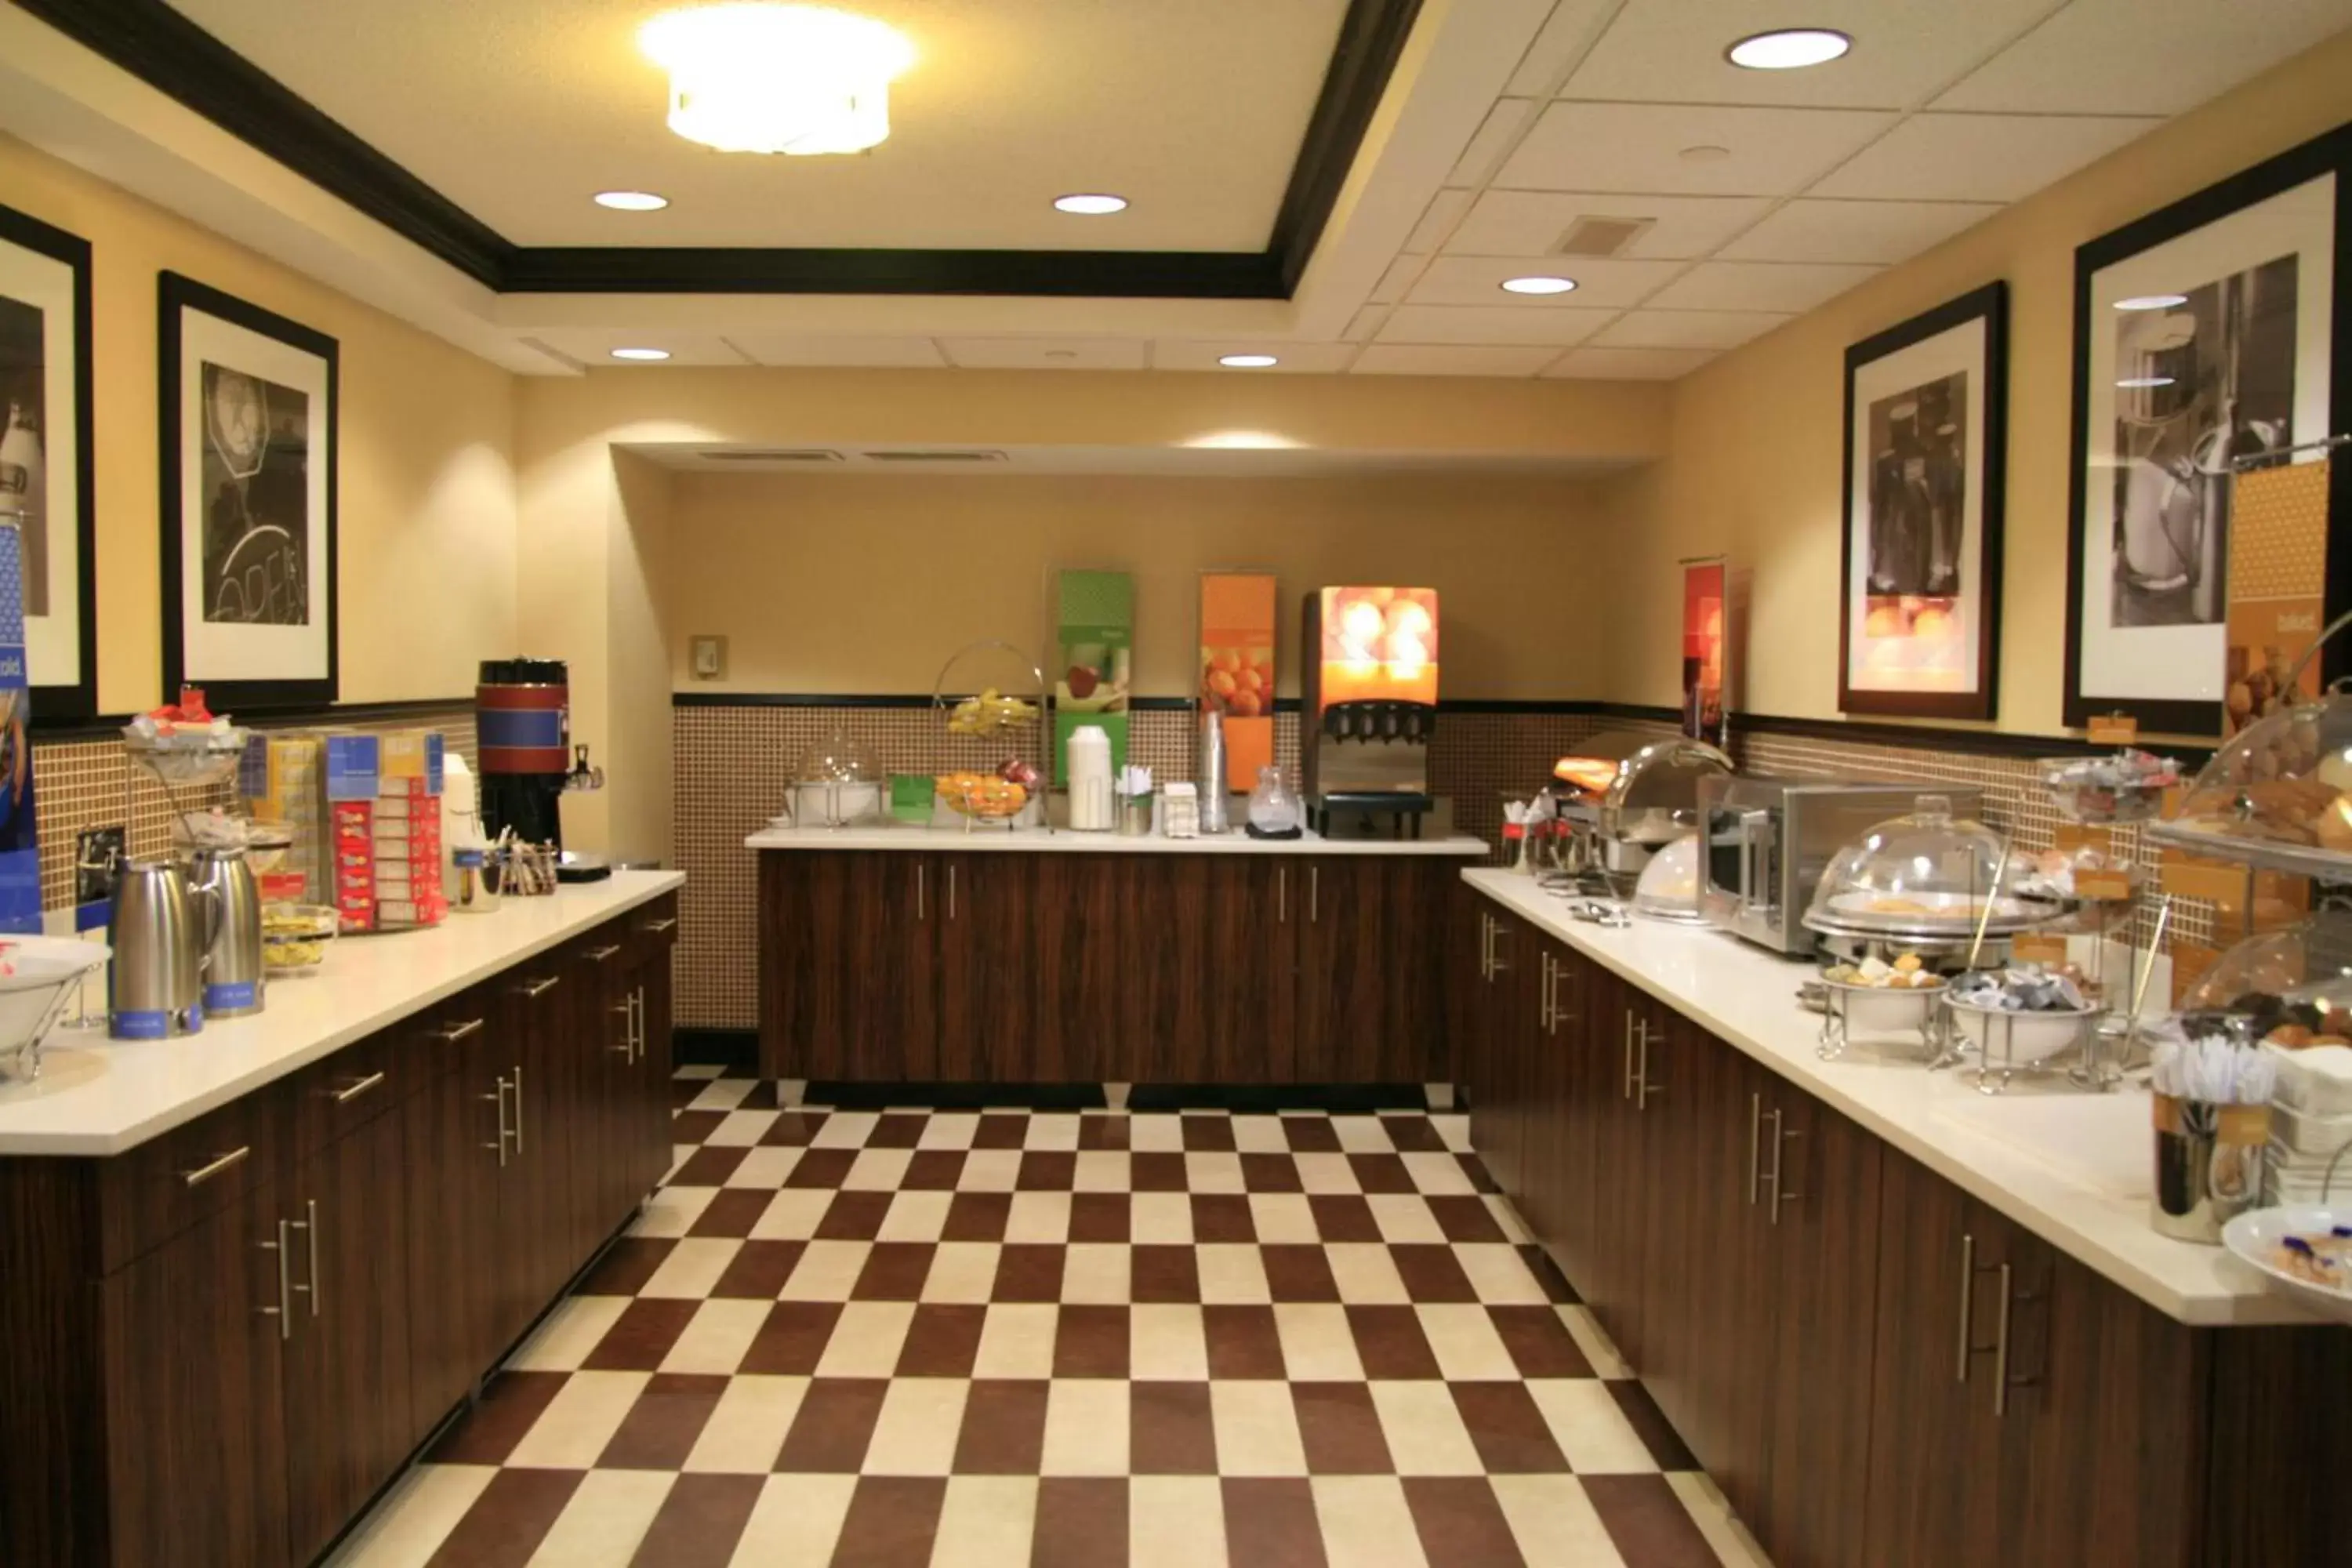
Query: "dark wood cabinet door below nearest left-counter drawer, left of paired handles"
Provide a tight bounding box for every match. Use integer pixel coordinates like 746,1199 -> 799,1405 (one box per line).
99,1185 -> 296,1568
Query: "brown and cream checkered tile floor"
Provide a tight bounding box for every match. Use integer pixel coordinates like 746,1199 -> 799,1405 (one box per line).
336,1069 -> 1762,1568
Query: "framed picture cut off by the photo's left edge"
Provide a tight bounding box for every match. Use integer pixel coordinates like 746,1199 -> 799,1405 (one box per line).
0,207 -> 99,720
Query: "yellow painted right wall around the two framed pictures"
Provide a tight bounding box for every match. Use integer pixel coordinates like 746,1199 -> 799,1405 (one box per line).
1597,33 -> 2352,734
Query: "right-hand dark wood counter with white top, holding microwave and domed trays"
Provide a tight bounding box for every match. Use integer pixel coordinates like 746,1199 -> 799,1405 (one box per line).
1454,872 -> 2352,1568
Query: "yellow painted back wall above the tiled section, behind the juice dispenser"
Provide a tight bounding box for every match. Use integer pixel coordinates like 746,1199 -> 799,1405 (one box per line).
663,473 -> 1606,699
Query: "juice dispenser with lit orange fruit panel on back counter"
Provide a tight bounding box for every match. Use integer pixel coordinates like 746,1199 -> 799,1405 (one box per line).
1298,588 -> 1437,839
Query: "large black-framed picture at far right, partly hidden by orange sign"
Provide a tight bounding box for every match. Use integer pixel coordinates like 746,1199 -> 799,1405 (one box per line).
2065,127 -> 2352,736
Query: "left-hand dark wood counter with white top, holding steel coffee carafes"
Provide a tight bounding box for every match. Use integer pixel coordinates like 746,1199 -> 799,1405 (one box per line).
0,872 -> 682,1568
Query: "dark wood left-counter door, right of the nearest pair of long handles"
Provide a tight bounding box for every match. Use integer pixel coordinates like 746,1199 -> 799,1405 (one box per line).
280,1112 -> 421,1563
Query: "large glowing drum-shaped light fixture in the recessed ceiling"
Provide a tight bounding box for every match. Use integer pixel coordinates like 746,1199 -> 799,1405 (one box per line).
637,5 -> 915,155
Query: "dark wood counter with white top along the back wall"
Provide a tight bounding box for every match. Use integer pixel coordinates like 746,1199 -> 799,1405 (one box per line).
748,827 -> 1489,1086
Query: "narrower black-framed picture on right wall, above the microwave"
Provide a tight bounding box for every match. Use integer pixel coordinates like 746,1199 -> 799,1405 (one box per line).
1837,282 -> 2009,720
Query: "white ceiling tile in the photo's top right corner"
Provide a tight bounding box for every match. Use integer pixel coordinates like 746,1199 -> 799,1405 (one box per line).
1936,0 -> 2352,115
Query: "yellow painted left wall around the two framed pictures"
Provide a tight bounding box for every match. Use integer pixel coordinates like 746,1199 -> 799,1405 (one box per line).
0,136 -> 515,713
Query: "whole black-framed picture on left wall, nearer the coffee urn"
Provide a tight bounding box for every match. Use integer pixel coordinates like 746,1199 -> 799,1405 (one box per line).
158,273 -> 336,713
